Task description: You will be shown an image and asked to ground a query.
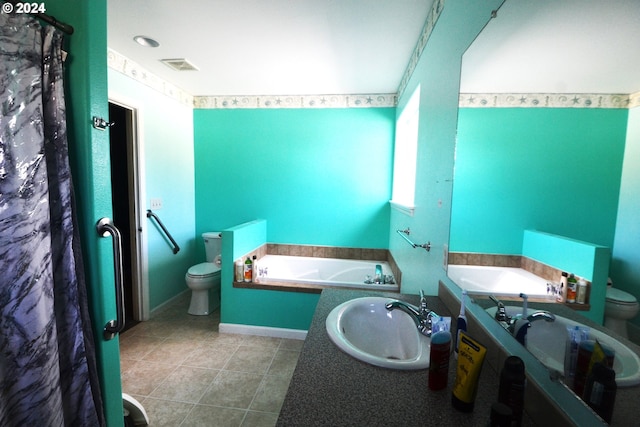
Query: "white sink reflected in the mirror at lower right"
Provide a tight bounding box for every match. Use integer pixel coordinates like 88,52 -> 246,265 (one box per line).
487,306 -> 640,387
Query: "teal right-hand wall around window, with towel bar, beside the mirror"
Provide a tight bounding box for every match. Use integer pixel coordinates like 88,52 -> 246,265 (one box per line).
389,0 -> 502,295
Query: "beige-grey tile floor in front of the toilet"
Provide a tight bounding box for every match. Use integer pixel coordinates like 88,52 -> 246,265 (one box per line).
120,293 -> 303,427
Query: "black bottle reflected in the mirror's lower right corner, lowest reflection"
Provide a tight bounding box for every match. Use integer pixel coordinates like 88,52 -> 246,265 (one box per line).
582,362 -> 618,424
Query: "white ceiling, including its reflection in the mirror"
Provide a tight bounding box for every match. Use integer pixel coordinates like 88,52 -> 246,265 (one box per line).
107,0 -> 640,96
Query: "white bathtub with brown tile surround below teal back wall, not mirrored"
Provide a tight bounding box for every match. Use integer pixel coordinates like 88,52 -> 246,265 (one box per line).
258,255 -> 398,291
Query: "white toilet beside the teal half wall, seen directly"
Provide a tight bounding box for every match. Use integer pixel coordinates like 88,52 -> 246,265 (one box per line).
185,232 -> 222,316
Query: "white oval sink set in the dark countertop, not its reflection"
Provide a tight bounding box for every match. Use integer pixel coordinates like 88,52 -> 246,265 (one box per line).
325,297 -> 431,370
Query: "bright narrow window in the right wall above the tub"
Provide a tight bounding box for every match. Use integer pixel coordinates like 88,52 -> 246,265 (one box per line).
391,86 -> 420,215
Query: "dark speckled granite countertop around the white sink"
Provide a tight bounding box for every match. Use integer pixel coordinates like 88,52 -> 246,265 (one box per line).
277,289 -> 533,427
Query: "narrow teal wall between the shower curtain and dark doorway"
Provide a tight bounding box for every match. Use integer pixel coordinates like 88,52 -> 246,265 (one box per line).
46,0 -> 123,427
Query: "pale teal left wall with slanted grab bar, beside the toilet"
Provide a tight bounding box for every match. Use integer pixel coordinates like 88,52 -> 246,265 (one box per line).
108,69 -> 196,310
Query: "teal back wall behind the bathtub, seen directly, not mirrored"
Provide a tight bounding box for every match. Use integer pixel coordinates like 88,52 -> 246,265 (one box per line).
193,108 -> 395,254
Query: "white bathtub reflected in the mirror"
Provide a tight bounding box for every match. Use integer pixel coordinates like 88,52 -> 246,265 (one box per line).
448,264 -> 554,300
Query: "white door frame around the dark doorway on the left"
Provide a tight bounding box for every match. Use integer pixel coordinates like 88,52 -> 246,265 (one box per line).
109,91 -> 150,321
